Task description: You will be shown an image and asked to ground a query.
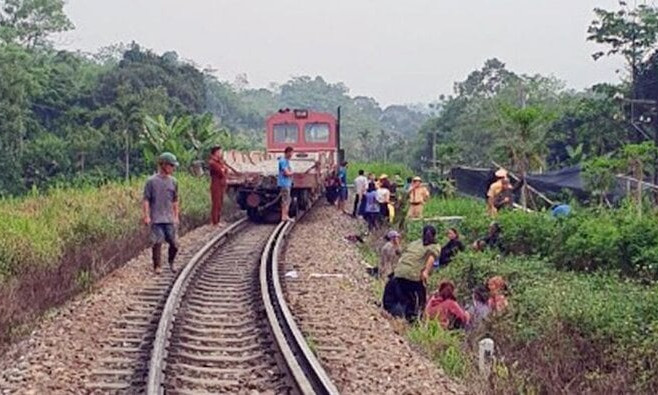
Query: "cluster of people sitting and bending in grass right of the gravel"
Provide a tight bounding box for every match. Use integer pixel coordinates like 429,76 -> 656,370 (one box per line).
377,223 -> 507,330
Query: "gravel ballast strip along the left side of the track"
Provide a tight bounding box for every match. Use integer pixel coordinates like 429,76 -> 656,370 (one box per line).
0,225 -> 224,394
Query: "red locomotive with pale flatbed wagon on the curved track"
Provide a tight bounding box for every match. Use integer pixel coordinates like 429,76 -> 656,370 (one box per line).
225,109 -> 340,222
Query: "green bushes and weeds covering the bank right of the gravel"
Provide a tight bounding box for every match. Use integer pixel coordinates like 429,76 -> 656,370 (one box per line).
407,199 -> 658,393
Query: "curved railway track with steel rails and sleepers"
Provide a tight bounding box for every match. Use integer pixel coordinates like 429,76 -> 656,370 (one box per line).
90,209 -> 337,394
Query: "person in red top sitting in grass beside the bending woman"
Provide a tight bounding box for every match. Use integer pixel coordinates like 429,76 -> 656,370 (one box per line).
425,281 -> 471,329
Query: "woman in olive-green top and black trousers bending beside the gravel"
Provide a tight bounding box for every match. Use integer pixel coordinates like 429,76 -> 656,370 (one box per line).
383,225 -> 441,322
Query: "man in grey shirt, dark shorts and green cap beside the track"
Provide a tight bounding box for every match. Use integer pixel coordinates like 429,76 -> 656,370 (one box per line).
142,152 -> 179,274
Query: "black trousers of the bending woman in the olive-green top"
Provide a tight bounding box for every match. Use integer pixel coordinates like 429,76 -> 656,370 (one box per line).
384,277 -> 427,322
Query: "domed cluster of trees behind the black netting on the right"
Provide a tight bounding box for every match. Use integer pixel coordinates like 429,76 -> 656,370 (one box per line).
414,59 -> 634,174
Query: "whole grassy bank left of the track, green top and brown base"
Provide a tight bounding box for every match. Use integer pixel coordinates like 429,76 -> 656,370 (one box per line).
0,174 -> 217,343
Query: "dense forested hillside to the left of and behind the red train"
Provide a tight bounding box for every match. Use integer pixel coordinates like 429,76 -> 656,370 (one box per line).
0,0 -> 427,196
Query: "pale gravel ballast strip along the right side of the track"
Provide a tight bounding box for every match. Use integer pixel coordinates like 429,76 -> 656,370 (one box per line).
284,203 -> 464,394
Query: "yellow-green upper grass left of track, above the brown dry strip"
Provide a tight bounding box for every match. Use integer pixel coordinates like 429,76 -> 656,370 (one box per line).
0,174 -> 209,284
